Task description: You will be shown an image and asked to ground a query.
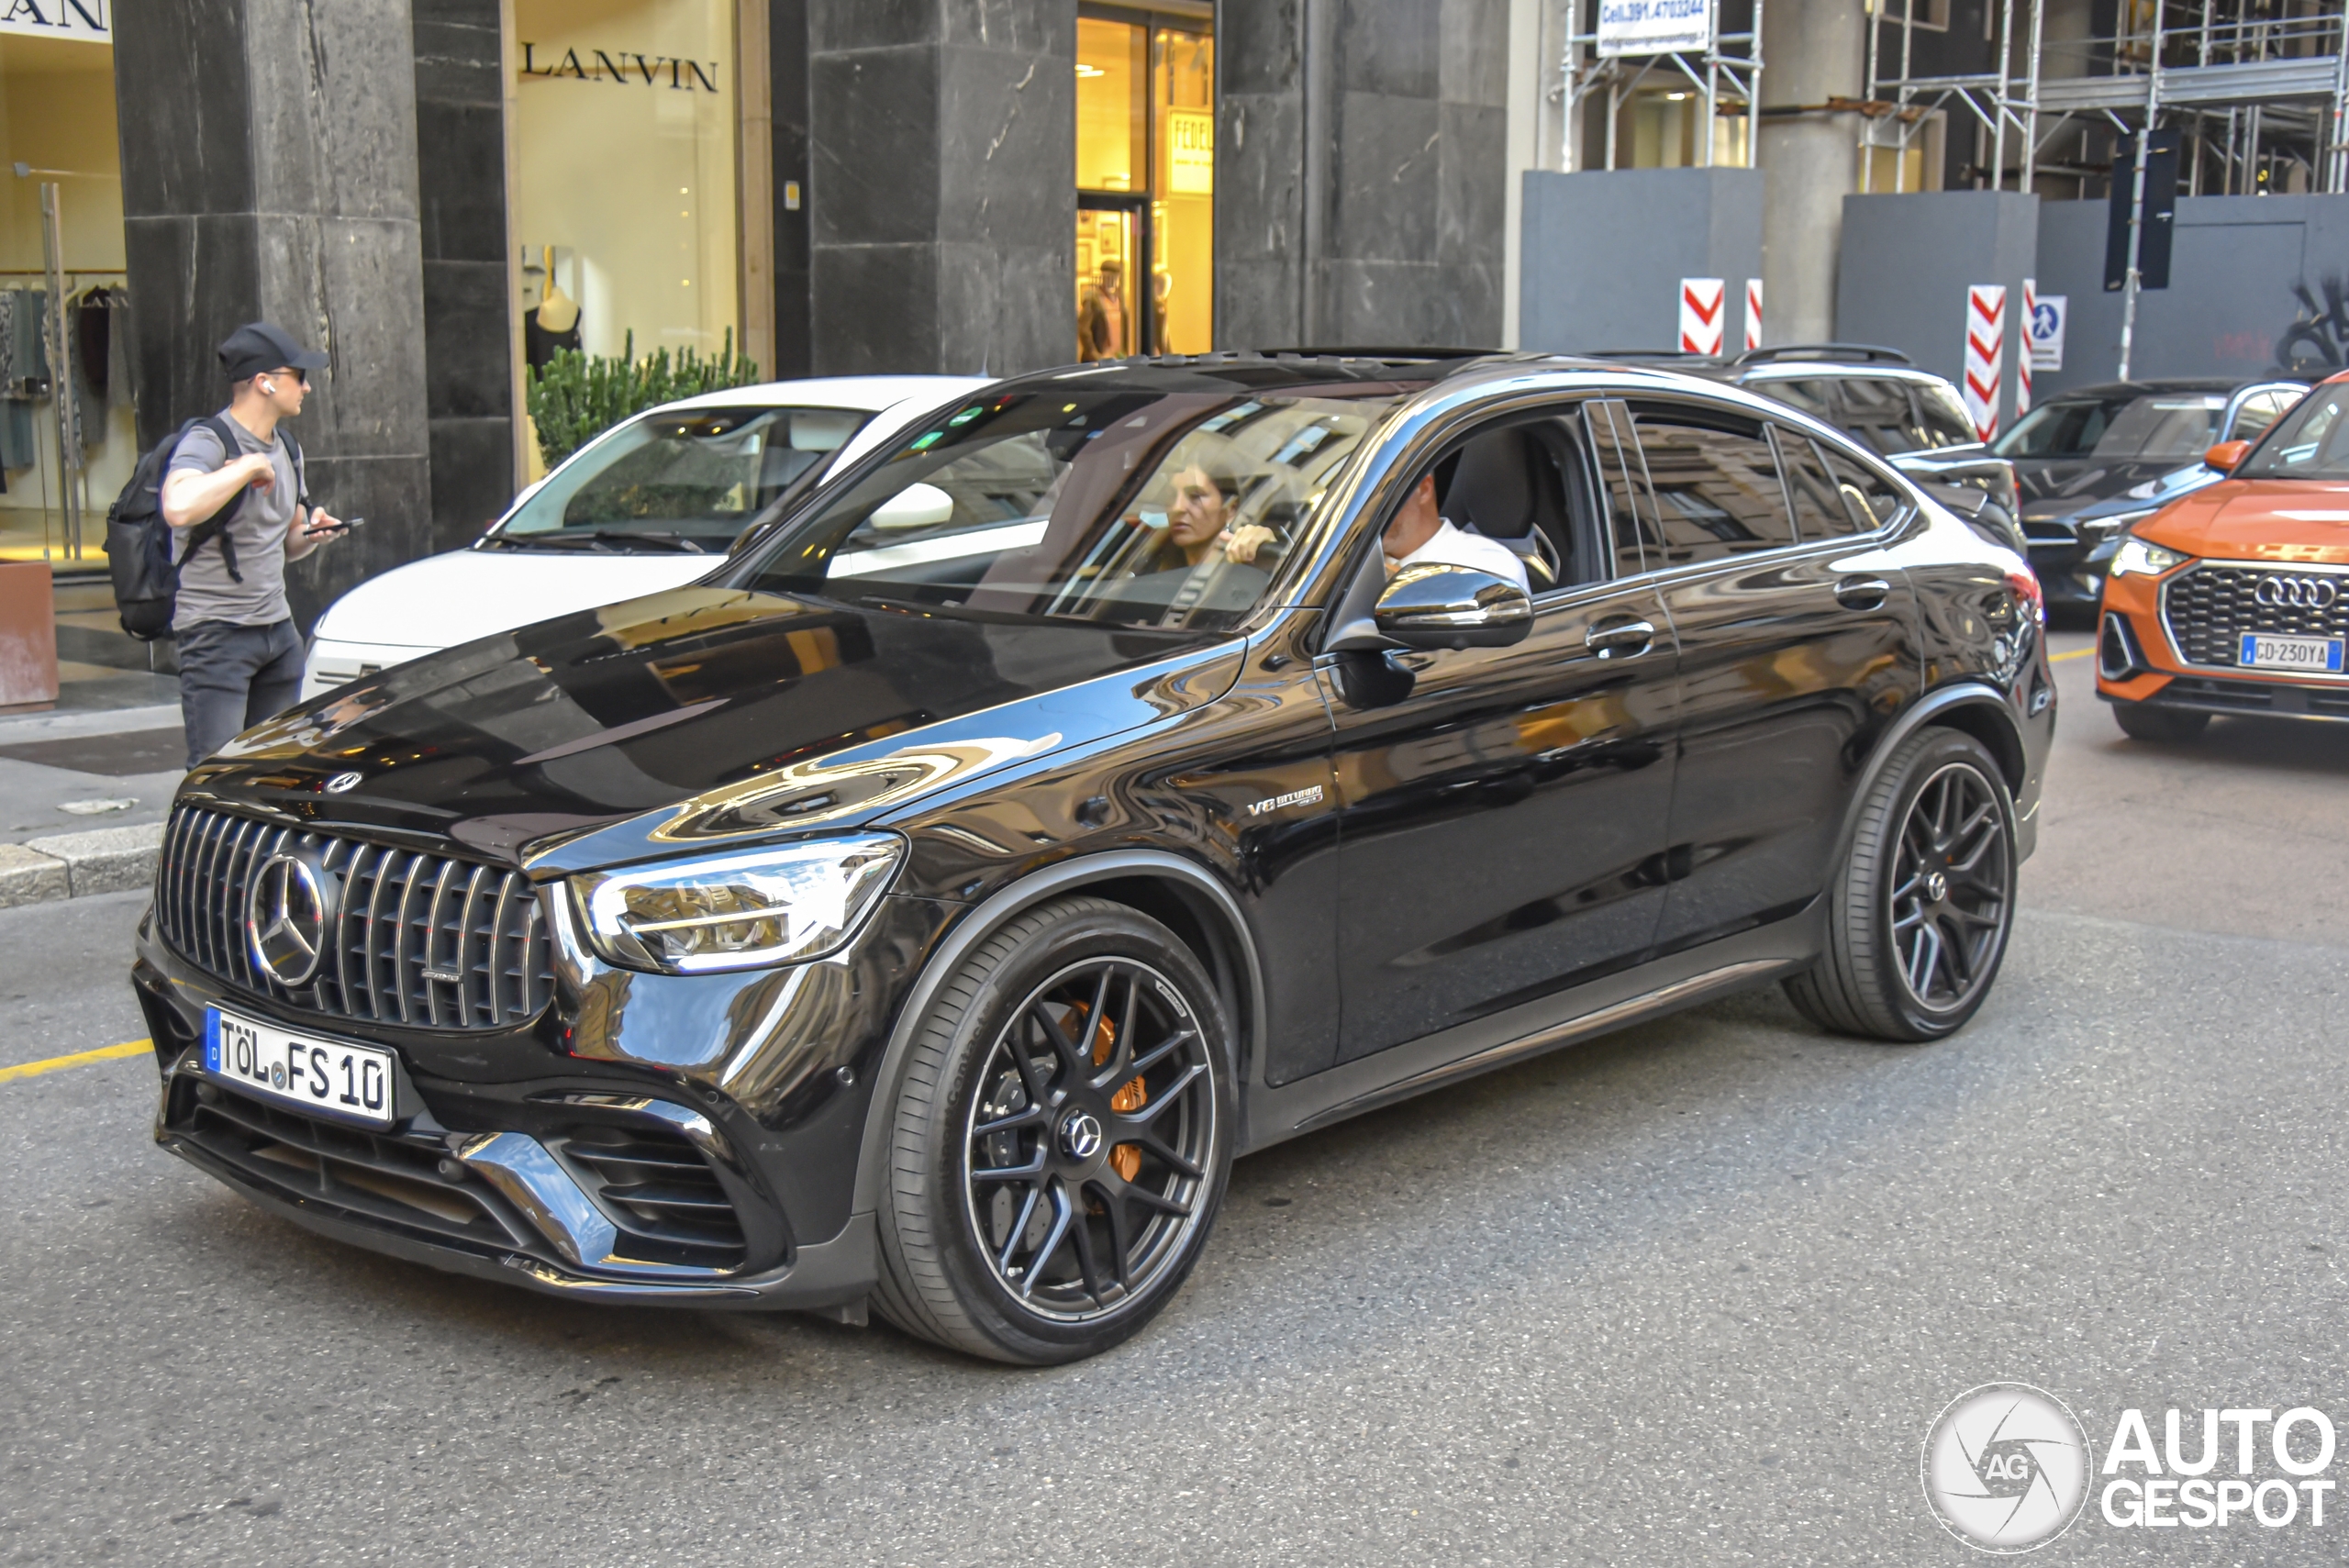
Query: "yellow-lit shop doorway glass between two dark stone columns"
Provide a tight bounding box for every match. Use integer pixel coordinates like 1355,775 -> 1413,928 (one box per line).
1075,12 -> 1215,359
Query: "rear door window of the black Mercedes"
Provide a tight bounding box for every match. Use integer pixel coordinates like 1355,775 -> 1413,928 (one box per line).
1637,408 -> 1795,566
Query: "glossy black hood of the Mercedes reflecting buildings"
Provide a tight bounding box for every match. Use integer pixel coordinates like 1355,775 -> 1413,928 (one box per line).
181,587 -> 1245,873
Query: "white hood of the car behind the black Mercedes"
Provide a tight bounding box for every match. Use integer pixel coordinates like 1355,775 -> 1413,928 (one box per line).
317,550 -> 721,648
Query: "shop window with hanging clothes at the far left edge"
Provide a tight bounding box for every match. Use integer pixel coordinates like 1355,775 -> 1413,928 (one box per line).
0,7 -> 139,566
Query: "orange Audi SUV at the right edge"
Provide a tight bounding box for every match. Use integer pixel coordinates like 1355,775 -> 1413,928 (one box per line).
2096,373 -> 2349,740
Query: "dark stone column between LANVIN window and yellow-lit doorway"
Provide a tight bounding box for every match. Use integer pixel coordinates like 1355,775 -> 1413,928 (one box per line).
803,0 -> 1075,375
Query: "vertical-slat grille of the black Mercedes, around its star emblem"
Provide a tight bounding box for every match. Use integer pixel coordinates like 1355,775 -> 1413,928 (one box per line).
155,807 -> 554,1029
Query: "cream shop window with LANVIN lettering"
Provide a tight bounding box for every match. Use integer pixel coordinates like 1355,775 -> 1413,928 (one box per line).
510,0 -> 738,398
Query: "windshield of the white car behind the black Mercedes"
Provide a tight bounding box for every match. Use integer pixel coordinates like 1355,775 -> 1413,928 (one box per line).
484,408 -> 872,554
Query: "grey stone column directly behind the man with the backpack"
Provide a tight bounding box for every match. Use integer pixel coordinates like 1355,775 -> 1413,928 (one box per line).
115,0 -> 437,627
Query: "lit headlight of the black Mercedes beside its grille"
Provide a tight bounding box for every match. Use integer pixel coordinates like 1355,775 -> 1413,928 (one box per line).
571,833 -> 905,974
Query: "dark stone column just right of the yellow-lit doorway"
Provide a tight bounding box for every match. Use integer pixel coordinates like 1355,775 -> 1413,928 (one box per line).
1215,0 -> 1508,348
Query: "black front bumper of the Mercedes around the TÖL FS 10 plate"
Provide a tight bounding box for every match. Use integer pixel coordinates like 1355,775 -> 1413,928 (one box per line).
131,899 -> 937,1310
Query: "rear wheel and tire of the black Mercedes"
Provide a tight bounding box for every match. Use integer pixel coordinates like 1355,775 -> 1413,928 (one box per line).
1786,726 -> 2015,1044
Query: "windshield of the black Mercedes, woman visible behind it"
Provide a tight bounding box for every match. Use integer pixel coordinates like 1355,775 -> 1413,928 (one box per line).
745,385 -> 1396,631
